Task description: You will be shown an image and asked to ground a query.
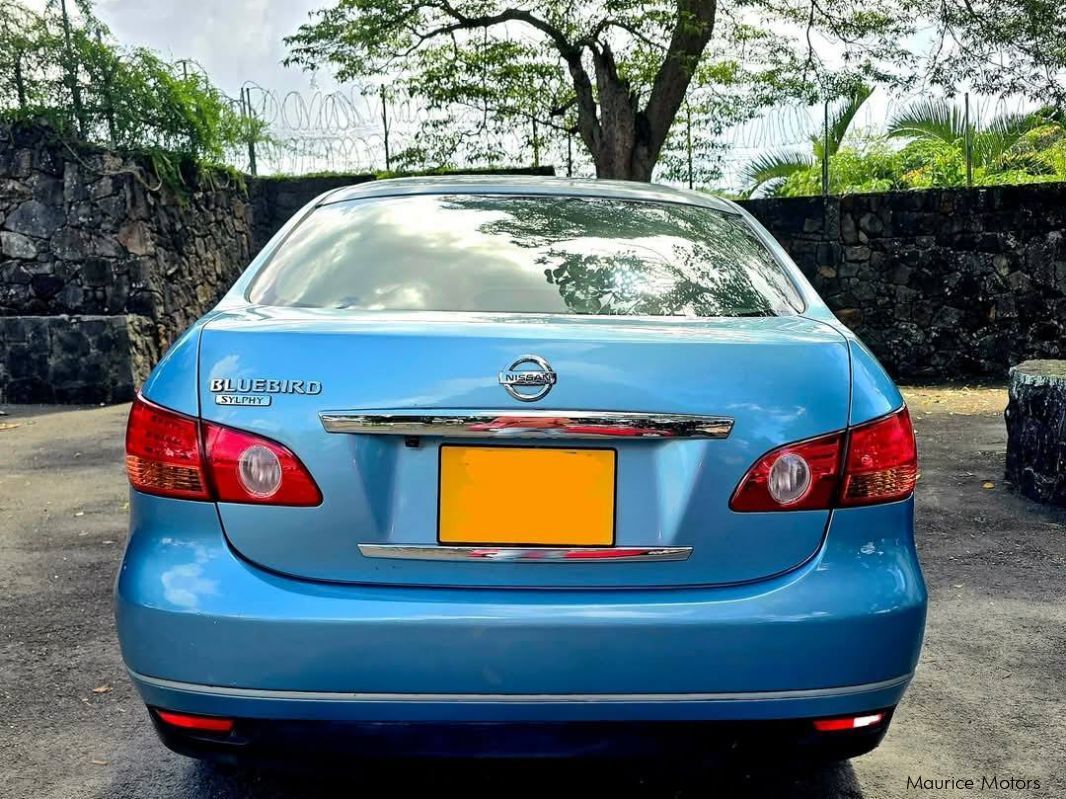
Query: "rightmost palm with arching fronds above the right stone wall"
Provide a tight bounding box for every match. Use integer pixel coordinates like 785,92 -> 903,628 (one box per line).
888,99 -> 1062,175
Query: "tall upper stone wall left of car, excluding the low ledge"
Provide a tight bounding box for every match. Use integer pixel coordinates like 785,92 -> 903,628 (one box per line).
0,126 -> 253,360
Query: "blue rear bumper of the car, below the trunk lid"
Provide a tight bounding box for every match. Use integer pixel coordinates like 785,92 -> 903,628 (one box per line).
116,495 -> 925,722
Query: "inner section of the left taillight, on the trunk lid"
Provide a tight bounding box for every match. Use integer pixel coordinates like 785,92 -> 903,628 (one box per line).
204,422 -> 322,506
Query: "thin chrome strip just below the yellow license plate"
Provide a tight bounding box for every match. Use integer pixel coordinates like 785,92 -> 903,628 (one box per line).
359,543 -> 692,564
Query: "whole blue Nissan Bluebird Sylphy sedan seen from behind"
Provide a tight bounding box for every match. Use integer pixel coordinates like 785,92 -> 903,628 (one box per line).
115,177 -> 926,761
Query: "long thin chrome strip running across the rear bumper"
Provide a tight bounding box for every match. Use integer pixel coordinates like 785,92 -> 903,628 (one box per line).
129,669 -> 914,704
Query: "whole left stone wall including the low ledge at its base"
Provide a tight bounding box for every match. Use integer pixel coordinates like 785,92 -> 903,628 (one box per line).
0,126 -> 254,402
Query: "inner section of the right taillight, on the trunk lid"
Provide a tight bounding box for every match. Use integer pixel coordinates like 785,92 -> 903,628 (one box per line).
729,433 -> 844,510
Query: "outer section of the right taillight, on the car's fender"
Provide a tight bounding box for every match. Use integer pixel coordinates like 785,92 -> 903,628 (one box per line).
840,407 -> 918,505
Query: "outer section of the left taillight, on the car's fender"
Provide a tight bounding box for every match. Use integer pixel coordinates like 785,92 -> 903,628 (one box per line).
126,396 -> 211,500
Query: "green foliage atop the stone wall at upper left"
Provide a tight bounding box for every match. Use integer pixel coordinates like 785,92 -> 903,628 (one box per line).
0,0 -> 264,183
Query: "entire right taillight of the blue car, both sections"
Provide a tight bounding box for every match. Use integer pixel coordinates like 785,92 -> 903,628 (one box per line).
729,407 -> 918,511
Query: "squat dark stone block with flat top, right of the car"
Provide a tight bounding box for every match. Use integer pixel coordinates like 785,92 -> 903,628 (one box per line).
1005,360 -> 1066,505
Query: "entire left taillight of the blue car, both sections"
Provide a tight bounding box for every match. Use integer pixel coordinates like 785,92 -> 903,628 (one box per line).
126,396 -> 322,505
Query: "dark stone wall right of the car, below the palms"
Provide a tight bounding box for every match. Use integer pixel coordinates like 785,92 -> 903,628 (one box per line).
744,183 -> 1066,378
